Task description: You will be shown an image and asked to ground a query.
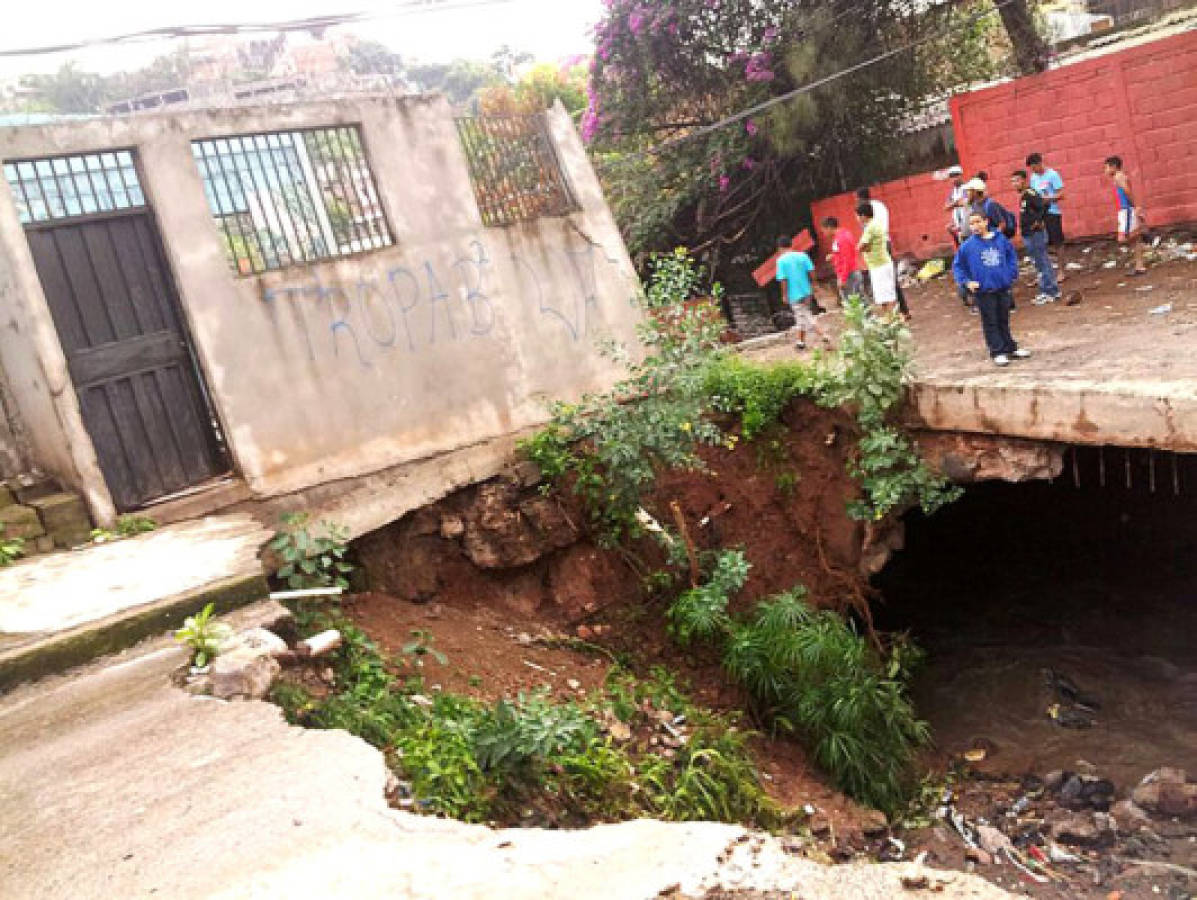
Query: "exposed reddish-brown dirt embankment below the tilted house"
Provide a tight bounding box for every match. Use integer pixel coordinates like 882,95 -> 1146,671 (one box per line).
346,402 -> 885,838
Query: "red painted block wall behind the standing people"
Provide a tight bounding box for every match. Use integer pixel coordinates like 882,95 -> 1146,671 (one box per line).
810,31 -> 1197,259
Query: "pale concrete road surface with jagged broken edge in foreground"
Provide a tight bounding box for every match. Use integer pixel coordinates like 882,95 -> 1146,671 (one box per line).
0,631 -> 1008,900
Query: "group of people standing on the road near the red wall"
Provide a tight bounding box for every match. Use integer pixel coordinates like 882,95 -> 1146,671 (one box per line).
777,153 -> 1147,366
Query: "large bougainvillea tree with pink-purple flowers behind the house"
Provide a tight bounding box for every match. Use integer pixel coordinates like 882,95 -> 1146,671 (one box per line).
581,0 -> 1024,280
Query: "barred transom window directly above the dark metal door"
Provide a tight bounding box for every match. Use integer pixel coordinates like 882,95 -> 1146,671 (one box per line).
4,150 -> 146,225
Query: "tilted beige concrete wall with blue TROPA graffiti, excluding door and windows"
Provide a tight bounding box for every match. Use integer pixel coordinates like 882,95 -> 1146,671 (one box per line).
0,98 -> 639,512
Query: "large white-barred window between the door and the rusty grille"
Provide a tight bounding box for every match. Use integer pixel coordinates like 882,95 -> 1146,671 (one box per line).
192,126 -> 394,275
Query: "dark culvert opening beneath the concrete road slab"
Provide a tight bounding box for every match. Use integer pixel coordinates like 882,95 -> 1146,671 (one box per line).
876,449 -> 1197,789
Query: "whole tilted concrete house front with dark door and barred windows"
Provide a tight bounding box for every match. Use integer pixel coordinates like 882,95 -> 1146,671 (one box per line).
0,97 -> 639,548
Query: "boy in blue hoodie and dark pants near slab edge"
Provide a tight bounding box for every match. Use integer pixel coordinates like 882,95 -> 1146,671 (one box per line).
952,211 -> 1031,366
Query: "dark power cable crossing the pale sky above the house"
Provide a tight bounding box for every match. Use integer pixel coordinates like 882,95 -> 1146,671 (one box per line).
0,0 -> 516,57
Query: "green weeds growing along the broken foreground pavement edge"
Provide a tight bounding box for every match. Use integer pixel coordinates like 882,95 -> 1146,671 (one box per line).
272,607 -> 779,826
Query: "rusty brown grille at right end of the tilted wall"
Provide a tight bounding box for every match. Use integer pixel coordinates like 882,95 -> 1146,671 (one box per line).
457,115 -> 581,225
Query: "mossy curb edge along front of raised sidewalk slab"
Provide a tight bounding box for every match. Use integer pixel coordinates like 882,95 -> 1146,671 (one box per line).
0,573 -> 269,694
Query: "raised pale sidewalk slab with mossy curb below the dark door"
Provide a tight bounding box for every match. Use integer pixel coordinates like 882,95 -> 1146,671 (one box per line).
0,513 -> 271,691
